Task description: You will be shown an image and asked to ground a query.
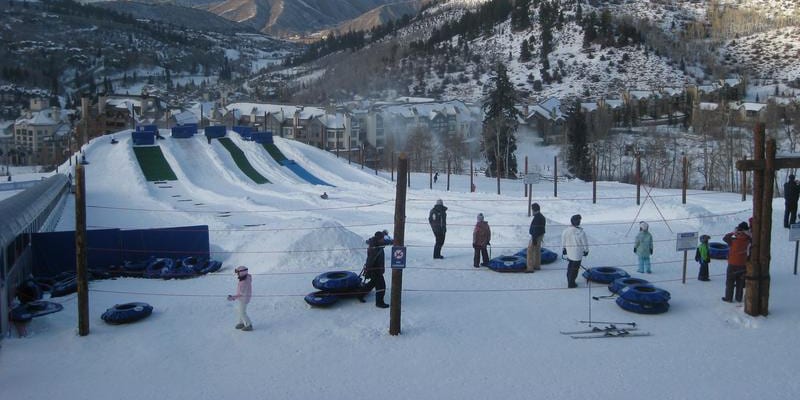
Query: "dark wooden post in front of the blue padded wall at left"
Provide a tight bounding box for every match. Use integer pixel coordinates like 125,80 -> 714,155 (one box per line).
75,164 -> 89,336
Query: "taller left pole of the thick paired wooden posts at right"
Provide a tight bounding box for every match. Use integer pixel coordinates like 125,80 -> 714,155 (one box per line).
744,125 -> 772,316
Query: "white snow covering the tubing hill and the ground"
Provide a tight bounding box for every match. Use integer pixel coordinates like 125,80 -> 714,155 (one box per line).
0,131 -> 800,400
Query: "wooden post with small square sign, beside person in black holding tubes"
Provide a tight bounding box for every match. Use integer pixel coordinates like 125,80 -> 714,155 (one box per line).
389,153 -> 408,336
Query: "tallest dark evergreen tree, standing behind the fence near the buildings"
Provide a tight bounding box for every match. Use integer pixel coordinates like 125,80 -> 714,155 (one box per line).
483,63 -> 522,178
